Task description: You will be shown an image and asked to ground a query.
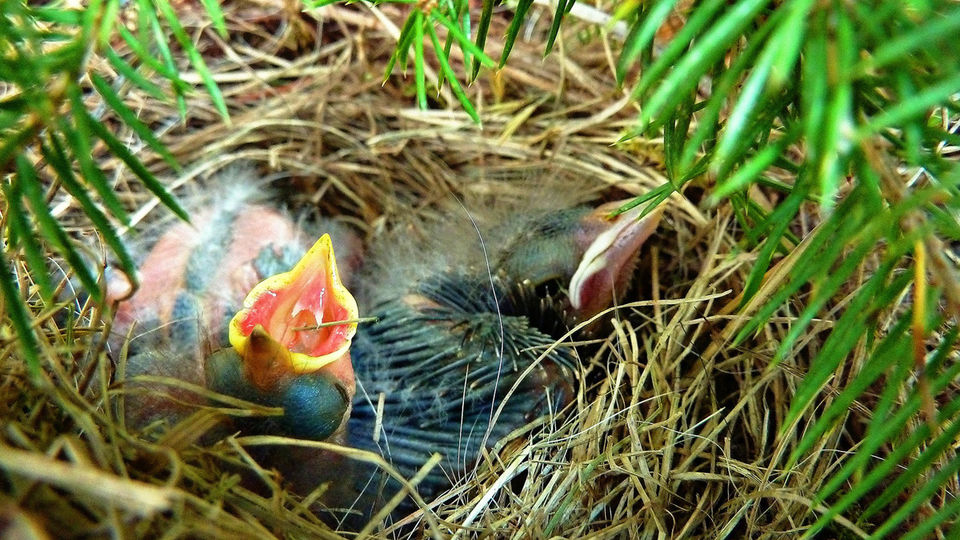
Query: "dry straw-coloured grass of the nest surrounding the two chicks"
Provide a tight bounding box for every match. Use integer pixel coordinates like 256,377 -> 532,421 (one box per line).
0,1 -> 838,538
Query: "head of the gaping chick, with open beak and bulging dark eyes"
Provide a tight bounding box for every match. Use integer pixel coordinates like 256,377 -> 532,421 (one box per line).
206,235 -> 358,439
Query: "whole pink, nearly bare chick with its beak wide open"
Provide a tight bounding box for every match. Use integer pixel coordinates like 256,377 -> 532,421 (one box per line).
108,166 -> 358,440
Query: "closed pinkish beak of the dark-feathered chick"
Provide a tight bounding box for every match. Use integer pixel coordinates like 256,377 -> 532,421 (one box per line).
569,201 -> 662,317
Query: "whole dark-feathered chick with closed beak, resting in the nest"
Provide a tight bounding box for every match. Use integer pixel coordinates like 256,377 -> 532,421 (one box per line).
338,192 -> 660,515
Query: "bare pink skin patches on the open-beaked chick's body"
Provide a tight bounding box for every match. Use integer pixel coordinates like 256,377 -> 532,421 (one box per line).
107,201 -> 356,430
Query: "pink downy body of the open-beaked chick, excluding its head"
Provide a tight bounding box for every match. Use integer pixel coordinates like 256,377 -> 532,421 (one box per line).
108,166 -> 357,434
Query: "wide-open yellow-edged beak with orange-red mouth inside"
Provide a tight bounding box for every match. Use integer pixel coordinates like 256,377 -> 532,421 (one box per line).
229,235 -> 358,389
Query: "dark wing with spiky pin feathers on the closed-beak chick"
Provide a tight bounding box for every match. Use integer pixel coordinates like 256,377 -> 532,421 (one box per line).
349,274 -> 575,496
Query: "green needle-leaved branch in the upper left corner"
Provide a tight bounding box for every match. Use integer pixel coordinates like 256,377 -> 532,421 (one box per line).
0,0 -> 227,380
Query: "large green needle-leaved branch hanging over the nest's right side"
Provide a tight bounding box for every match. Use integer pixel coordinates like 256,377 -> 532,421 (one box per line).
617,0 -> 960,536
